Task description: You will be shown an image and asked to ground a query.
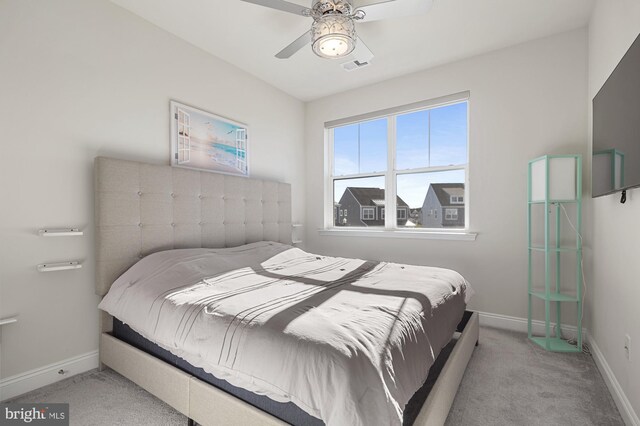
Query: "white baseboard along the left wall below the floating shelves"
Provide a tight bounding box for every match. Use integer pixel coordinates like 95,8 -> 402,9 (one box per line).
0,351 -> 98,402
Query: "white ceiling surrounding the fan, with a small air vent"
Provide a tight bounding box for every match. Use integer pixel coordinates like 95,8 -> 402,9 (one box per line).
112,0 -> 594,101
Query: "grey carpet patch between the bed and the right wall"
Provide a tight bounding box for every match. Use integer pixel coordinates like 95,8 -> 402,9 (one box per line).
446,327 -> 624,426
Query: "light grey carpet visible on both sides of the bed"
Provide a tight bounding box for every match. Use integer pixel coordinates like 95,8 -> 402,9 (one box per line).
10,327 -> 624,426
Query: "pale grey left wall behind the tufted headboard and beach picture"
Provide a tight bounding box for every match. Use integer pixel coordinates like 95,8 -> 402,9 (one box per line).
0,0 -> 305,378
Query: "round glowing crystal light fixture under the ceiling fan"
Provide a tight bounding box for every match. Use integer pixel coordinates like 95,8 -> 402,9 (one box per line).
311,13 -> 357,59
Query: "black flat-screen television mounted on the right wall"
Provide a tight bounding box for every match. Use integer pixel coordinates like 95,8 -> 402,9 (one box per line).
591,30 -> 640,202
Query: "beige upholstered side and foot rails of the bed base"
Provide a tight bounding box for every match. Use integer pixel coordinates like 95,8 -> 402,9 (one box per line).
100,312 -> 479,426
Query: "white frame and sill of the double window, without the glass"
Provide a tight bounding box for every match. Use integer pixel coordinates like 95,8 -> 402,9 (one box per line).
320,92 -> 477,240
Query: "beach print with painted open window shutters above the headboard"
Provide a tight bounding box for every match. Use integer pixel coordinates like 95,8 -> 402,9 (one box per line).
170,101 -> 249,176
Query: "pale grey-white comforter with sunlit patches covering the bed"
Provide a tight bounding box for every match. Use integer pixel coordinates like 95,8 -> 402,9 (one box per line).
100,242 -> 470,426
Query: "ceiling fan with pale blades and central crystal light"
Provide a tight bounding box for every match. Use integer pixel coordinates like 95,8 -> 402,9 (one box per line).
242,0 -> 433,63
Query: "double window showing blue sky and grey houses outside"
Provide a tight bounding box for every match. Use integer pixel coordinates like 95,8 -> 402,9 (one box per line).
325,93 -> 468,229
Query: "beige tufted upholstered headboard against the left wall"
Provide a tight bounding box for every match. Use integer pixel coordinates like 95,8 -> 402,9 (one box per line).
94,157 -> 291,296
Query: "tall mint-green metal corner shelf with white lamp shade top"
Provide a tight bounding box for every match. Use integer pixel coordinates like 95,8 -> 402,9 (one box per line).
527,155 -> 582,352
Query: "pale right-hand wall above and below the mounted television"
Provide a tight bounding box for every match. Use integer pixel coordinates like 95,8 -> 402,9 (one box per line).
587,0 -> 640,421
